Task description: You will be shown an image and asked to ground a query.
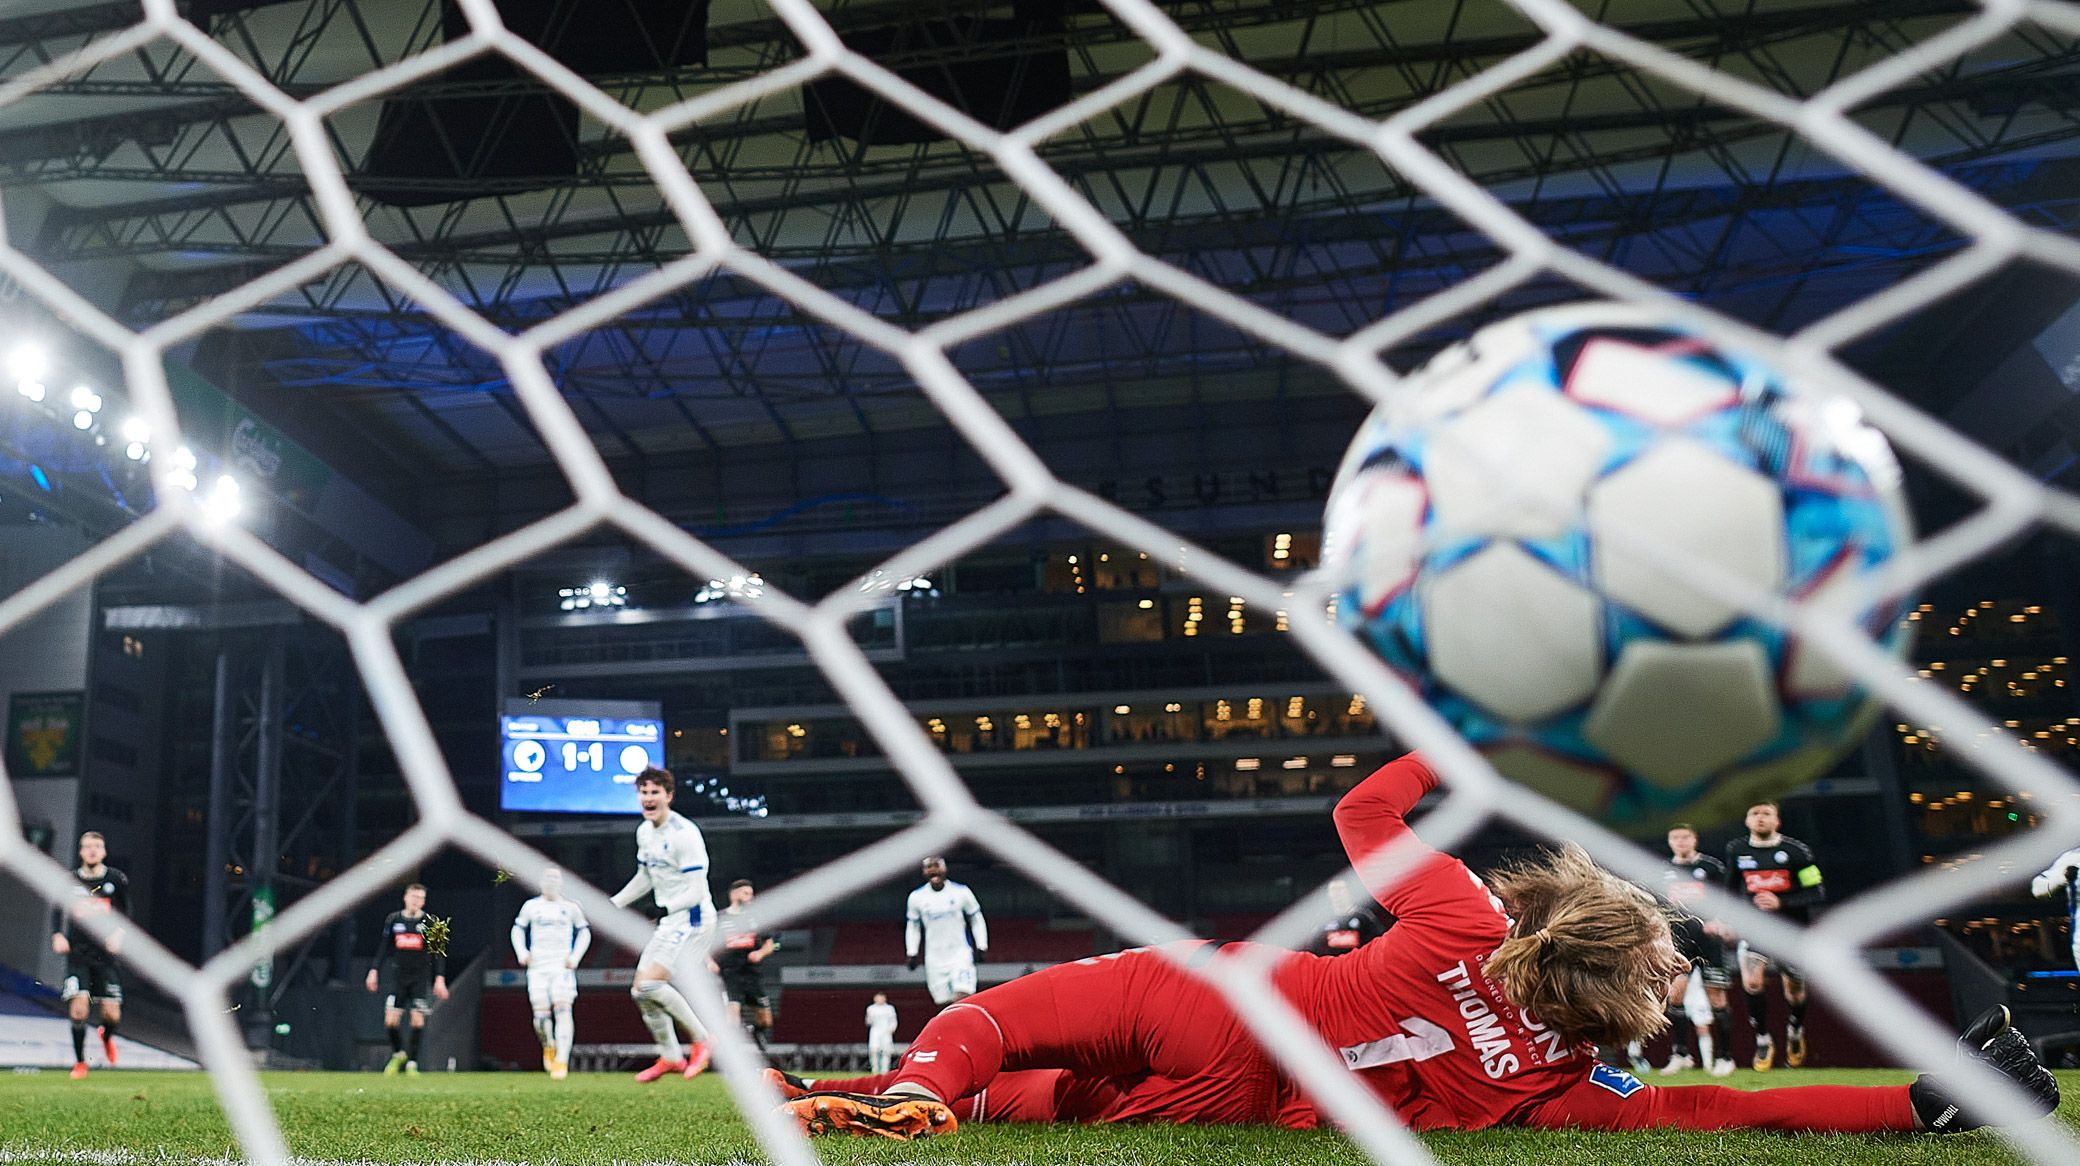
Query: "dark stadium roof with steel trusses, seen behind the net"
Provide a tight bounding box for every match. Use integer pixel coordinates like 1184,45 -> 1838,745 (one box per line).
0,0 -> 2080,581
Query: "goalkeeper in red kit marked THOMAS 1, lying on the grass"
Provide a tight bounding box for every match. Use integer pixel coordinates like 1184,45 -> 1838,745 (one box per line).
774,754 -> 2057,1139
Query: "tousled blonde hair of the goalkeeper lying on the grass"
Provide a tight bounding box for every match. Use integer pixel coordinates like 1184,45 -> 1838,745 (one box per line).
1485,844 -> 1683,1045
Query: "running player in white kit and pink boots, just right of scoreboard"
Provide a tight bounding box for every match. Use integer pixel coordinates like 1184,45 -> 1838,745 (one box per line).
614,767 -> 716,1081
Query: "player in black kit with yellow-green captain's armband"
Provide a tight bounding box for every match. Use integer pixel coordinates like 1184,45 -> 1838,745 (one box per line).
1726,802 -> 1826,1072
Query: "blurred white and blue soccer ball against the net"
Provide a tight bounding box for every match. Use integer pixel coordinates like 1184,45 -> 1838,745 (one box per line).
1323,303 -> 1912,833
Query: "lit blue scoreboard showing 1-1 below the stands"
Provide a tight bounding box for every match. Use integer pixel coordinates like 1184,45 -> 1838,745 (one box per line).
499,700 -> 664,815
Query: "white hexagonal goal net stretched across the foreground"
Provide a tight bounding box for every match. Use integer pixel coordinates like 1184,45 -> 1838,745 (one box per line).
0,0 -> 2080,1166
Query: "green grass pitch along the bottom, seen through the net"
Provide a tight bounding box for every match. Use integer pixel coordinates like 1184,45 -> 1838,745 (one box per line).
0,1070 -> 2080,1166
